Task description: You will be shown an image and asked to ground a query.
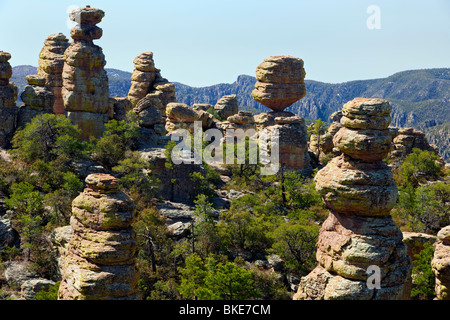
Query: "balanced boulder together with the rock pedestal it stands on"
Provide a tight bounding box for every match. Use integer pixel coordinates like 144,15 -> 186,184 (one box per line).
252,56 -> 311,174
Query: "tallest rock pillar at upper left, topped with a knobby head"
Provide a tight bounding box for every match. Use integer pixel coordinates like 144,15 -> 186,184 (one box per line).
61,6 -> 112,139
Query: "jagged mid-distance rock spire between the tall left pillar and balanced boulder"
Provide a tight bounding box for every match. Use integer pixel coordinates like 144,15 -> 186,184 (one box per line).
128,52 -> 176,135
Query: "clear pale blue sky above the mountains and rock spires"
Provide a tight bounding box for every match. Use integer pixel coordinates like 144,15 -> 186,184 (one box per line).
0,0 -> 450,86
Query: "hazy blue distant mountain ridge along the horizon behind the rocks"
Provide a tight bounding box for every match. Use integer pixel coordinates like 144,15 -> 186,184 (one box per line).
11,66 -> 450,161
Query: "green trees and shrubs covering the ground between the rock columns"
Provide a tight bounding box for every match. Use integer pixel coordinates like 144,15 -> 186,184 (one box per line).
0,110 -> 450,300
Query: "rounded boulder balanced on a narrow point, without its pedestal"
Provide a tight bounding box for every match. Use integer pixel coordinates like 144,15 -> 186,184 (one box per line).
252,56 -> 306,111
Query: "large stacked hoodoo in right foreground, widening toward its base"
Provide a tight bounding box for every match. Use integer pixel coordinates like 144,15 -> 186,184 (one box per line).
294,98 -> 411,300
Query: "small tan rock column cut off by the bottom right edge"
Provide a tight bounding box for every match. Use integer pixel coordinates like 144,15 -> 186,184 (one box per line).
431,226 -> 450,300
